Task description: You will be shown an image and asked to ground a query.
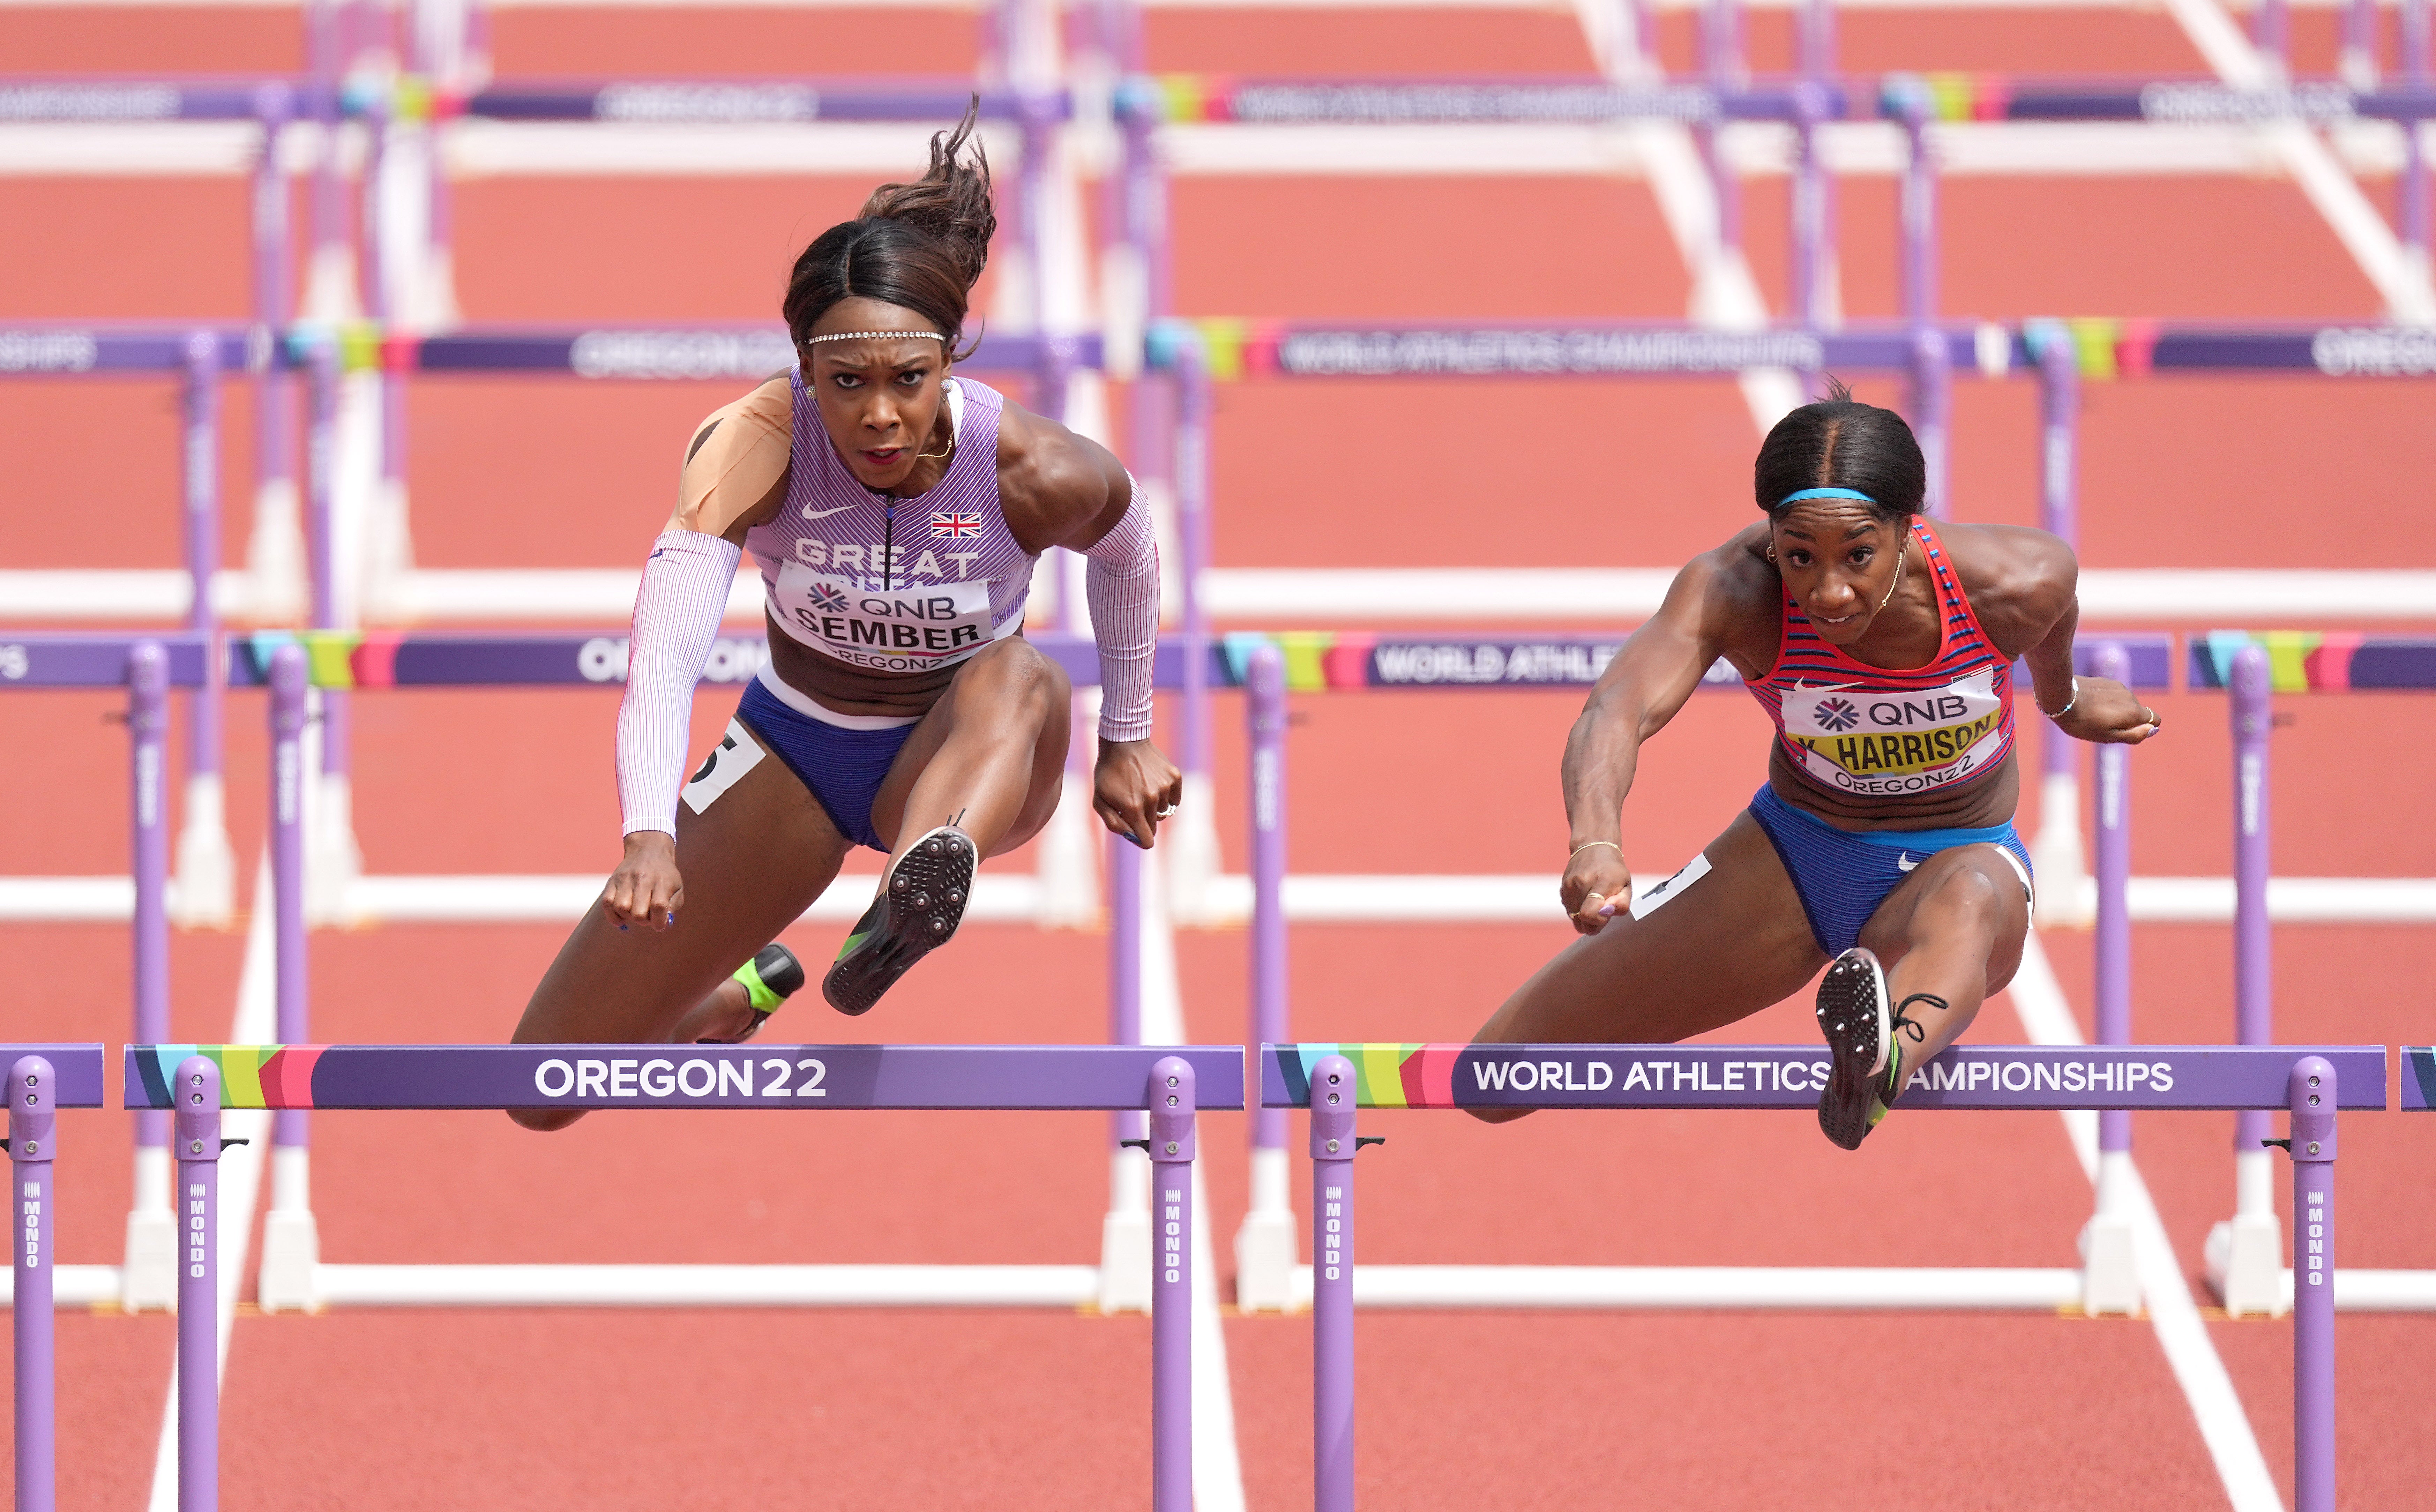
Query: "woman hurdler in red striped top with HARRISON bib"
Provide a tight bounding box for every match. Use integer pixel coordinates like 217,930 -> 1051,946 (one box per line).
1479,387 -> 2158,1149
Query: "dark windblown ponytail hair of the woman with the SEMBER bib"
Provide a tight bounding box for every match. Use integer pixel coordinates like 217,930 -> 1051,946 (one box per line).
779,95 -> 999,358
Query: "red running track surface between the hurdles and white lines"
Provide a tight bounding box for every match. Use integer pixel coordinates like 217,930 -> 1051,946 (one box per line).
0,10 -> 2436,1512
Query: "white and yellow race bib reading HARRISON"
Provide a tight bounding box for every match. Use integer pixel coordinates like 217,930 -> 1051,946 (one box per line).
1781,667 -> 2005,794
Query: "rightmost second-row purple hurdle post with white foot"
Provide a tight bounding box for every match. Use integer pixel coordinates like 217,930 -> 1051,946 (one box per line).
2207,645 -> 2285,1317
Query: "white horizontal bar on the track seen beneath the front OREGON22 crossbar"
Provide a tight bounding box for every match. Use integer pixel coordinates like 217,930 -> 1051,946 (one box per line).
312,1266 -> 1101,1310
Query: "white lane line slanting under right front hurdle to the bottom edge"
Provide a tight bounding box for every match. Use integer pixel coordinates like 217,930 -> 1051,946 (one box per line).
2007,933 -> 2282,1512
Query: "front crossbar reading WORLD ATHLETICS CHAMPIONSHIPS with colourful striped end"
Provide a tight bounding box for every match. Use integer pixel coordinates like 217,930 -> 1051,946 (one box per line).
1260,1042 -> 2387,1110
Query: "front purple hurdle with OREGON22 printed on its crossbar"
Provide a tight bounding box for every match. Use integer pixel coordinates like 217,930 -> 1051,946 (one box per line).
127,1045 -> 1245,1512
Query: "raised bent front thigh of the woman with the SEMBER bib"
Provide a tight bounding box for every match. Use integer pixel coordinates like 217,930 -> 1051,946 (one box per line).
872,638 -> 1074,855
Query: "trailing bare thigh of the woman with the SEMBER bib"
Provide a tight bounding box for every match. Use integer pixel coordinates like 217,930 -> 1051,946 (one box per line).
516,740 -> 848,1045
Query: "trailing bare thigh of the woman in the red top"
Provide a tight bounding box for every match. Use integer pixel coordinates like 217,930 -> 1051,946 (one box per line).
1479,813 -> 1827,1045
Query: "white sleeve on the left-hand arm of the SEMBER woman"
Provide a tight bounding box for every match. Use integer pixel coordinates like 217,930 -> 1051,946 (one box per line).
616,531 -> 743,835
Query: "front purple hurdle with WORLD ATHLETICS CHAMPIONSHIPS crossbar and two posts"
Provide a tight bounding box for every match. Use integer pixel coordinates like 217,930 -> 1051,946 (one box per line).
1260,1045 -> 2377,1512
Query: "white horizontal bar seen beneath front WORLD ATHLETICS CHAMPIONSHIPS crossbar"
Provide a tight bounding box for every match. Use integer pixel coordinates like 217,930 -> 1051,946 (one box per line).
1293,1266 -> 2083,1312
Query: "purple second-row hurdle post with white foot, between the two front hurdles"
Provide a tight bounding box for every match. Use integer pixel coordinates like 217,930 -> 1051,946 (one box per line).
1235,645 -> 1298,1312
